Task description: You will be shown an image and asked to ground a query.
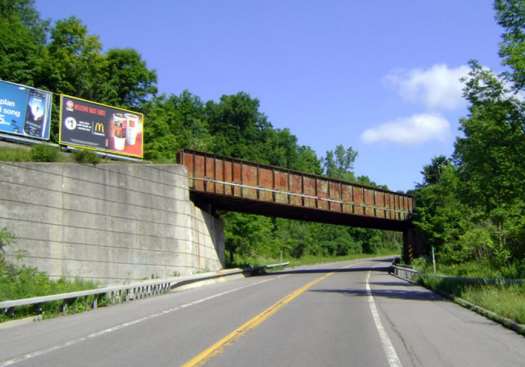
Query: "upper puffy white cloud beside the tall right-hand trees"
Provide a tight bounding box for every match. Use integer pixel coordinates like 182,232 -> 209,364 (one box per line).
385,64 -> 470,110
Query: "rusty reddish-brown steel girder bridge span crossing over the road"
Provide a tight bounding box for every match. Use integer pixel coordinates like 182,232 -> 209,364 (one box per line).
178,150 -> 422,259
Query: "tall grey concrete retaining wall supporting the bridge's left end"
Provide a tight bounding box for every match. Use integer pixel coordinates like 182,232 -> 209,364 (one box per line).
0,162 -> 224,284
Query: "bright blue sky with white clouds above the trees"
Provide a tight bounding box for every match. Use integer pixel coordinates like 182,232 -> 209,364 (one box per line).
36,0 -> 501,190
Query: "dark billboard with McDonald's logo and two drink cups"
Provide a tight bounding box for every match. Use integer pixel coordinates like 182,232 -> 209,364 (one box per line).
59,95 -> 144,158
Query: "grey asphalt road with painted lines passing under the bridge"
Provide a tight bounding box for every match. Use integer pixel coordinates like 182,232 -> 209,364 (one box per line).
0,260 -> 525,367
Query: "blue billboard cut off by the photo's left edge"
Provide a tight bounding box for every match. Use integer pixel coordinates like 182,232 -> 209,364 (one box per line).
0,80 -> 53,140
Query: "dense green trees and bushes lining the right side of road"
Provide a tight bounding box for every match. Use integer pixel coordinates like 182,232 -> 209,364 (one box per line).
415,0 -> 525,277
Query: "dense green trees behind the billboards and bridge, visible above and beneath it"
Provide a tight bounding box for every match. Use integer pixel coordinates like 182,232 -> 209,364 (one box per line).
0,0 -> 401,268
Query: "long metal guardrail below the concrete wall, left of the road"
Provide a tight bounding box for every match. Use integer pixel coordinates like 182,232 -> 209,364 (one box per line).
0,269 -> 243,315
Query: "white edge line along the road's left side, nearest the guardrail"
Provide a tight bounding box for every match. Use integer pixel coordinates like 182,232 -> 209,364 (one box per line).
0,275 -> 280,367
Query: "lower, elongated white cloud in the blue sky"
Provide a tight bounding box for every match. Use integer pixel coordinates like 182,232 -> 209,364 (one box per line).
361,114 -> 450,144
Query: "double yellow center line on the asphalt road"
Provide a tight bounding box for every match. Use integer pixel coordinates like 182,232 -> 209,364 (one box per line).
182,273 -> 334,367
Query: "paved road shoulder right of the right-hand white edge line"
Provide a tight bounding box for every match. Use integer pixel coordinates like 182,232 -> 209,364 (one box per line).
370,272 -> 525,367
